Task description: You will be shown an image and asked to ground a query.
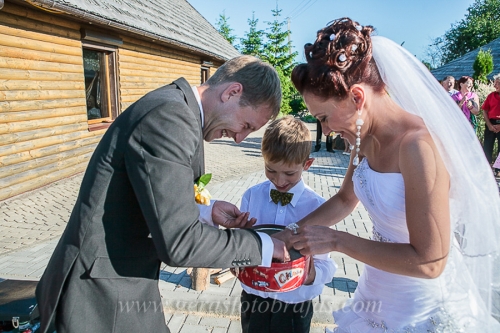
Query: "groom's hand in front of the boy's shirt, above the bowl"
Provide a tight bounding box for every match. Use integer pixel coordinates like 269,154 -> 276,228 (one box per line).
212,201 -> 257,229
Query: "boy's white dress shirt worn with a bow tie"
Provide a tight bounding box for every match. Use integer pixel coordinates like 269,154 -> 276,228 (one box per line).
240,179 -> 337,304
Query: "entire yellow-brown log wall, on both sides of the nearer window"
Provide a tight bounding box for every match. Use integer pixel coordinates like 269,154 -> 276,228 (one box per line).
0,2 -> 221,200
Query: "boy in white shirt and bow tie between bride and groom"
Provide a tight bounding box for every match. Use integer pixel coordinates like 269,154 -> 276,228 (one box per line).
241,116 -> 336,333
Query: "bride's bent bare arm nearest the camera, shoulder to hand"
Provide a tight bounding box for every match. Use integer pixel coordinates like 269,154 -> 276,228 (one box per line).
292,133 -> 450,278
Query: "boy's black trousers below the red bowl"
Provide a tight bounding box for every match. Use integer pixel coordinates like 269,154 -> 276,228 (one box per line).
241,291 -> 313,333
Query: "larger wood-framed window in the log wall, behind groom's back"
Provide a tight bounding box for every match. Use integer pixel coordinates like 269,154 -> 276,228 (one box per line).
83,43 -> 118,131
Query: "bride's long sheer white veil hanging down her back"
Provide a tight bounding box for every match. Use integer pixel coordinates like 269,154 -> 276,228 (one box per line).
372,36 -> 500,319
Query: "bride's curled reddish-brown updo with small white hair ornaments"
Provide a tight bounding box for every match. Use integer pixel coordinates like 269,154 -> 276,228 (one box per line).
292,17 -> 384,99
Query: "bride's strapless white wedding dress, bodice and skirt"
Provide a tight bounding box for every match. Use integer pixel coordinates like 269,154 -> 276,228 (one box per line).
333,158 -> 500,333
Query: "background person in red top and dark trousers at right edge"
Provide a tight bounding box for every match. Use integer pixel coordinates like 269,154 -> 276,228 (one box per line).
481,73 -> 500,177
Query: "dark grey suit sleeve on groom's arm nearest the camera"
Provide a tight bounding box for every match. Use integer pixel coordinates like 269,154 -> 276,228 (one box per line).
125,102 -> 261,267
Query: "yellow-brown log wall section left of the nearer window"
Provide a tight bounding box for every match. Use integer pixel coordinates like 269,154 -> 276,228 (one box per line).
0,3 -> 104,200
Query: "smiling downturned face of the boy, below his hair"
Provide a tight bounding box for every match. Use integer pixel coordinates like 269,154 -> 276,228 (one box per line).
264,158 -> 314,192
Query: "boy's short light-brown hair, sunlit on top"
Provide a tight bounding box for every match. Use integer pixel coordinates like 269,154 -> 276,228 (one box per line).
262,116 -> 311,165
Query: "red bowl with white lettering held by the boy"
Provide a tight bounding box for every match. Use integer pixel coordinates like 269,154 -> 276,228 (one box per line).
237,224 -> 311,292
